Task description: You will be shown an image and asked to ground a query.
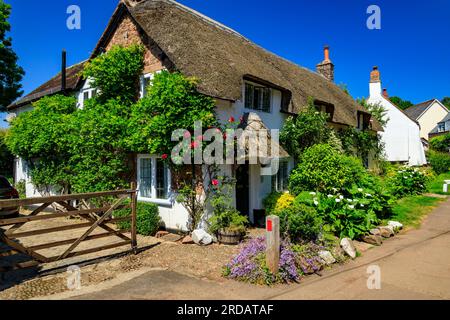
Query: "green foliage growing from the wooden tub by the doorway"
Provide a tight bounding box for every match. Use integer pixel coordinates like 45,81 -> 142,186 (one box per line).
209,177 -> 248,233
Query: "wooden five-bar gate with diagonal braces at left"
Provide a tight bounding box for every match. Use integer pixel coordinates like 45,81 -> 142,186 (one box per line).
0,184 -> 137,272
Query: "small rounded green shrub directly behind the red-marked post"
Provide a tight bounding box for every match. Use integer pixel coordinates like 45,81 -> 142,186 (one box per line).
274,202 -> 322,243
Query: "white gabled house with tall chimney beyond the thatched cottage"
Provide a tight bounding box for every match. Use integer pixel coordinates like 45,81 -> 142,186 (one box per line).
368,67 -> 427,166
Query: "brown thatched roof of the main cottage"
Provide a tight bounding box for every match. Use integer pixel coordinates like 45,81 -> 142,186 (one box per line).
122,0 -> 381,130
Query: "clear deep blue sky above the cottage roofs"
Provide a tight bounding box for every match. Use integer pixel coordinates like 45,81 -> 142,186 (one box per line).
1,0 -> 450,126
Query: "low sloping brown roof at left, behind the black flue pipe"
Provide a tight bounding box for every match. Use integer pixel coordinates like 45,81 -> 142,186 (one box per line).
8,61 -> 86,110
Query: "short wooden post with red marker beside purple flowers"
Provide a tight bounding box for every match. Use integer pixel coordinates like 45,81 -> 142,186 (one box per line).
266,216 -> 280,274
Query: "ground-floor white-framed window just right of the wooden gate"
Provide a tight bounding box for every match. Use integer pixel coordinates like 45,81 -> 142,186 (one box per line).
137,155 -> 170,202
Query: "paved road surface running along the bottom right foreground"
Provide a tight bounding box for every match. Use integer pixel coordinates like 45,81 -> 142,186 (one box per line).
45,200 -> 450,300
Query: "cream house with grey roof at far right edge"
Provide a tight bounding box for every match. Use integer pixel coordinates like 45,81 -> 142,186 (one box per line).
405,99 -> 449,140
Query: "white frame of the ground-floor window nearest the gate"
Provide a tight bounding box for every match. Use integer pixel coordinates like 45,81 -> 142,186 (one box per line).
136,154 -> 173,206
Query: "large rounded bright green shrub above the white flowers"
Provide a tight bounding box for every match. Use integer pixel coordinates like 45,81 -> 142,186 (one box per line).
289,144 -> 367,195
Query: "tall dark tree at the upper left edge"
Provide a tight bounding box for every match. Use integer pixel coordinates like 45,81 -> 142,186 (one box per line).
0,0 -> 25,112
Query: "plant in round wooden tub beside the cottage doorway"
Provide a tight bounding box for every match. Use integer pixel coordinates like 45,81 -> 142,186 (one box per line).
209,177 -> 248,244
